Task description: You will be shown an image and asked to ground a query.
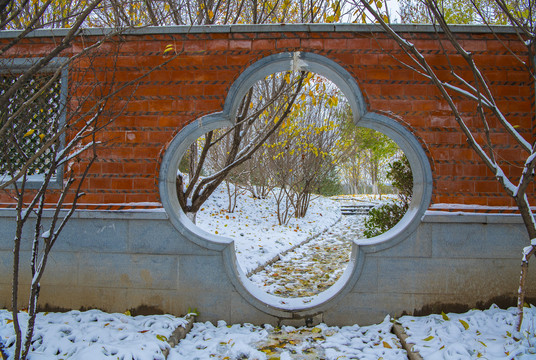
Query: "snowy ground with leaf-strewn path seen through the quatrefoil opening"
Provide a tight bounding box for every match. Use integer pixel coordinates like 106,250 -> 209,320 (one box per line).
196,185 -> 402,301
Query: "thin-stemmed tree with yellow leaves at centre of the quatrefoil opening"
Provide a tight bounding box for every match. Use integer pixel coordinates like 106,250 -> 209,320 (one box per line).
272,74 -> 347,218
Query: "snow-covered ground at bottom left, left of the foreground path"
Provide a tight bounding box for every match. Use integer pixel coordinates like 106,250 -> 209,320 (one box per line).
0,310 -> 188,360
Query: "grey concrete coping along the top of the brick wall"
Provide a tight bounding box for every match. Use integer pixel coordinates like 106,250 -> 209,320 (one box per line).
0,23 -> 516,39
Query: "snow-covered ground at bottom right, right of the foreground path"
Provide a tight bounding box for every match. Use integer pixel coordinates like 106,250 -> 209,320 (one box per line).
398,305 -> 536,360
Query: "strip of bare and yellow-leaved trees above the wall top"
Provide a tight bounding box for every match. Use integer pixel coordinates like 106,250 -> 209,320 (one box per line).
0,0 -> 524,30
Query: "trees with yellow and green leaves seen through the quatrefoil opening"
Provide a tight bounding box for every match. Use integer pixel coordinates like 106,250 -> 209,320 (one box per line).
177,72 -> 400,224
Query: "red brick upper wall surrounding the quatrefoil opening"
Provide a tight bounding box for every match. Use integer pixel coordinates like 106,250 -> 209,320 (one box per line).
0,32 -> 535,212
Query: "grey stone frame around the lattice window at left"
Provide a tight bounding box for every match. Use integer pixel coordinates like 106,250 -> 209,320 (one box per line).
0,57 -> 69,189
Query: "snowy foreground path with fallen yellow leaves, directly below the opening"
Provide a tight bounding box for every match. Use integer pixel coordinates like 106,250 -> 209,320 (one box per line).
168,317 -> 407,360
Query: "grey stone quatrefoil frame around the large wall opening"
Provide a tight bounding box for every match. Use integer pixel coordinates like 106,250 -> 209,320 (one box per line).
159,52 -> 432,318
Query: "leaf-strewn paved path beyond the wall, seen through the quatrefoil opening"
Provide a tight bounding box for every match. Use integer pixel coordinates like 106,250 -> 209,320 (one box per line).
250,216 -> 366,297
